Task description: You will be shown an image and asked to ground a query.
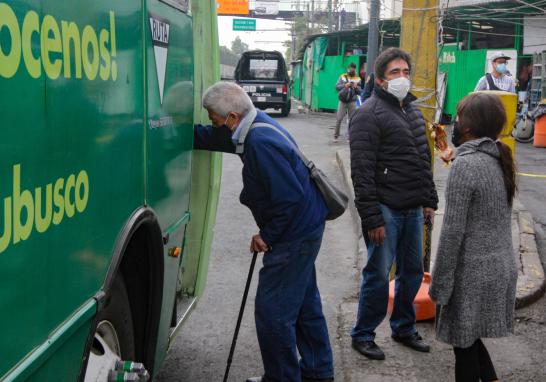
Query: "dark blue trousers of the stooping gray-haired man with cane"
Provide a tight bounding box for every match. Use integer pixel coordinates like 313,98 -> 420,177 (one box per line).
255,226 -> 334,382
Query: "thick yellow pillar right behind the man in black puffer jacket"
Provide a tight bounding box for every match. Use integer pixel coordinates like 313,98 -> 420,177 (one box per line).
400,0 -> 438,271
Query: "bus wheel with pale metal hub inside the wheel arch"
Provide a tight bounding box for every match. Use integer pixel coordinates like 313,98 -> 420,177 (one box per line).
84,275 -> 135,382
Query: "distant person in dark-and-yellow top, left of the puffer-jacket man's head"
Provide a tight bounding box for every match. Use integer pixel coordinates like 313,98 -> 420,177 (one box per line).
334,62 -> 360,142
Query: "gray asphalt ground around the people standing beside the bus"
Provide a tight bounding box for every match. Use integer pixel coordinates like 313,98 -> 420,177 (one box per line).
156,112 -> 546,382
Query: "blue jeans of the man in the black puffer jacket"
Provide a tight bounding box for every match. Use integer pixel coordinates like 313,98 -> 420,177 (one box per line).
351,204 -> 424,341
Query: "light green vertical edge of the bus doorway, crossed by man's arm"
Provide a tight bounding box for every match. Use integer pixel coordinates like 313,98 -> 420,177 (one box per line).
182,0 -> 222,297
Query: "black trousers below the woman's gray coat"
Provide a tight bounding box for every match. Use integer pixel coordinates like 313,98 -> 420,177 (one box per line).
453,339 -> 498,382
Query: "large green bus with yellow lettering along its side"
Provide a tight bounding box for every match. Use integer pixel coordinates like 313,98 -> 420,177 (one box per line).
0,0 -> 221,382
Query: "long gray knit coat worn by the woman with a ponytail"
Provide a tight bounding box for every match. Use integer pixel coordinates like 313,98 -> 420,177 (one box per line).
429,138 -> 517,348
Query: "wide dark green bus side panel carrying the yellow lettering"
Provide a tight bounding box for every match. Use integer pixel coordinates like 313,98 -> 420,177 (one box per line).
0,0 -> 144,376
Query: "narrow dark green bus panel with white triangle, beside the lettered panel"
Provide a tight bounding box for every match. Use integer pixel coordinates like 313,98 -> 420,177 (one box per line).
145,0 -> 194,370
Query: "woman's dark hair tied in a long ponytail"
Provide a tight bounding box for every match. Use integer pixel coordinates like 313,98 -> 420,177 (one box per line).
457,93 -> 517,205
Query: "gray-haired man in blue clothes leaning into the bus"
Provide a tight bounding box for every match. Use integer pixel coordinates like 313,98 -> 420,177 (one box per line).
194,82 -> 334,382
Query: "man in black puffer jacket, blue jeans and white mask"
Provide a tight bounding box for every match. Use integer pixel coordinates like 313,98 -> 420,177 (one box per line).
349,48 -> 438,359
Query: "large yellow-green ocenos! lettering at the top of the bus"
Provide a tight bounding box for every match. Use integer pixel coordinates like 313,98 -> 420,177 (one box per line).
0,3 -> 118,81
